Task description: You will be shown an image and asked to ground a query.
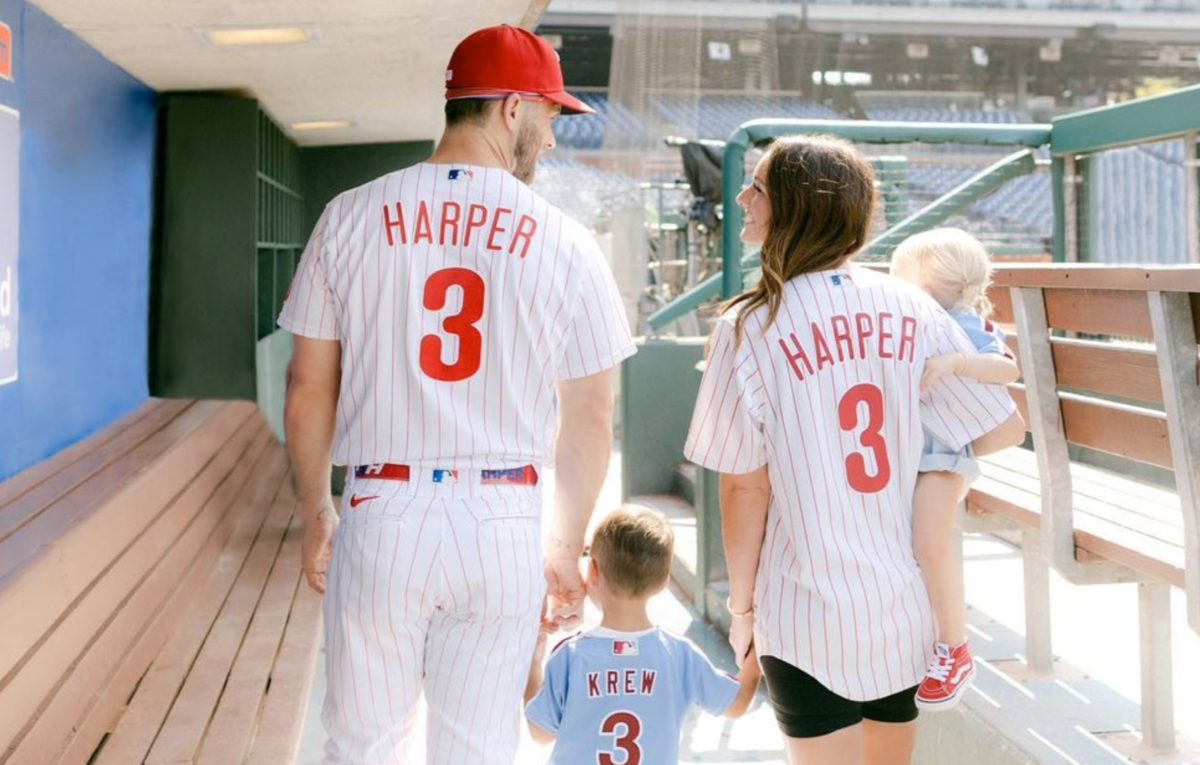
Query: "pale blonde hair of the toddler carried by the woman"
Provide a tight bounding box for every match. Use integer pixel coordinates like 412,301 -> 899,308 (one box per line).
892,228 -> 992,319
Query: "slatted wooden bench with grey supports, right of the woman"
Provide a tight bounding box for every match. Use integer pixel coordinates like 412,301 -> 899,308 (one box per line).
962,265 -> 1200,749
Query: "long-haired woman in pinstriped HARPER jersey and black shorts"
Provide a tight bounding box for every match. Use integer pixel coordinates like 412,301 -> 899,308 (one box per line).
685,137 -> 1024,765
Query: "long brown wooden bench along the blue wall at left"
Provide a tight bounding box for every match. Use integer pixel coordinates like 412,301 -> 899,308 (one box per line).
0,399 -> 320,765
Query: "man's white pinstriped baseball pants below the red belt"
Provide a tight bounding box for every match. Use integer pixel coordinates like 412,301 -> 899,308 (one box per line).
322,479 -> 545,765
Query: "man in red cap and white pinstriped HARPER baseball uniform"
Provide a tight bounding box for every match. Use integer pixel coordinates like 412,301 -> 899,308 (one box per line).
280,26 -> 634,765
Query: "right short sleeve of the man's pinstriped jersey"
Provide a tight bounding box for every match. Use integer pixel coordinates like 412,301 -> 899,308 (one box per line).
558,230 -> 636,380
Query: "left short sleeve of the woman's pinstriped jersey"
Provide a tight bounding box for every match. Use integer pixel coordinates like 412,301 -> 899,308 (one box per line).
683,318 -> 767,474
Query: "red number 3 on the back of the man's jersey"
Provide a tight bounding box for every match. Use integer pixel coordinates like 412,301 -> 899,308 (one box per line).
421,269 -> 486,383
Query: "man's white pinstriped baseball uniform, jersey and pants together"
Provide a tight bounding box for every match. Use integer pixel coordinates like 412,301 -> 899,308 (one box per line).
280,163 -> 634,765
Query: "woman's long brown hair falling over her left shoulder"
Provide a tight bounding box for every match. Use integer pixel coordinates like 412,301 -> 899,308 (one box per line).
720,135 -> 875,341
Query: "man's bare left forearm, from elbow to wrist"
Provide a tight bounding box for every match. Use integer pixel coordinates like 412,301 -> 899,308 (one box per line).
283,386 -> 337,514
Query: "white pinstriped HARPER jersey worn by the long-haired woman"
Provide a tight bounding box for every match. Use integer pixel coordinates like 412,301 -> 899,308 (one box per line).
684,267 -> 1014,701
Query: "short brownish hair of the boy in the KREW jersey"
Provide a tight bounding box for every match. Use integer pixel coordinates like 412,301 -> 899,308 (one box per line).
589,505 -> 674,597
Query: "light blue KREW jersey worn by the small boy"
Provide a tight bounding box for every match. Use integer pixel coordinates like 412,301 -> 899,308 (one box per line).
526,628 -> 738,765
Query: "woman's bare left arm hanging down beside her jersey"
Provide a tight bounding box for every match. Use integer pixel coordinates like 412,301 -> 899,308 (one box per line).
720,466 -> 770,667
